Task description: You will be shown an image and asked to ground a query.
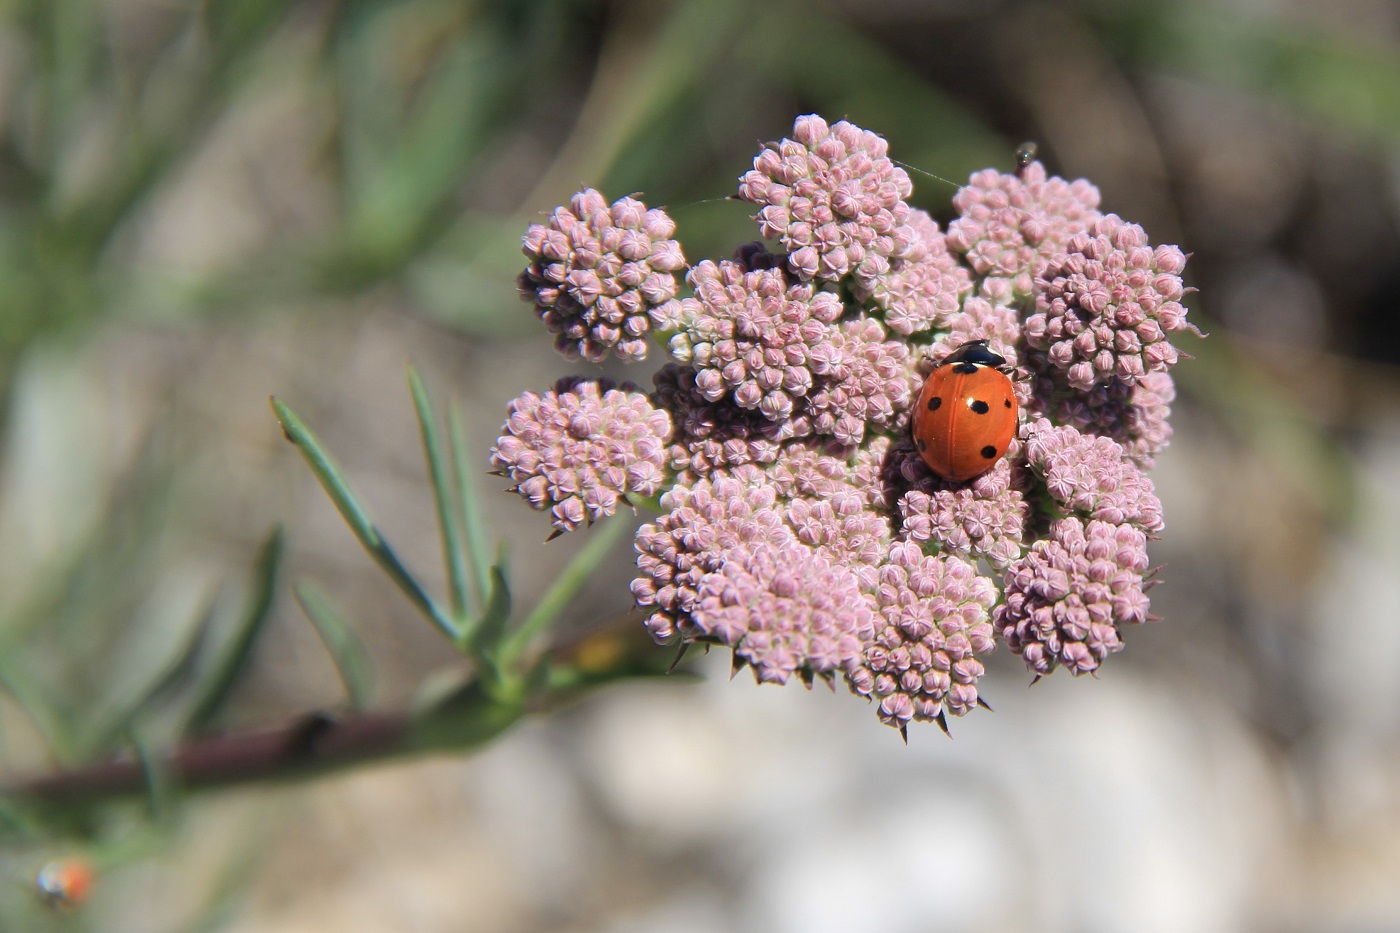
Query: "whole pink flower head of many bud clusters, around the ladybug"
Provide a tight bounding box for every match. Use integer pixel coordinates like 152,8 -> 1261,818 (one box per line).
493,115 -> 1196,731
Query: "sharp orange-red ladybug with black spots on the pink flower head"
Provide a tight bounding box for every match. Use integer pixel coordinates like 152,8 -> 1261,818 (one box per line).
913,340 -> 1018,482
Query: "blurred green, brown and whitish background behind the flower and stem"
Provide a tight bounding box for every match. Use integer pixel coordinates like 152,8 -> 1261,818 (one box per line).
0,0 -> 1400,933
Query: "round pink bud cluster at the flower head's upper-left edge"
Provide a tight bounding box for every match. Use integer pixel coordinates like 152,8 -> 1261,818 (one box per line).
519,188 -> 686,363
